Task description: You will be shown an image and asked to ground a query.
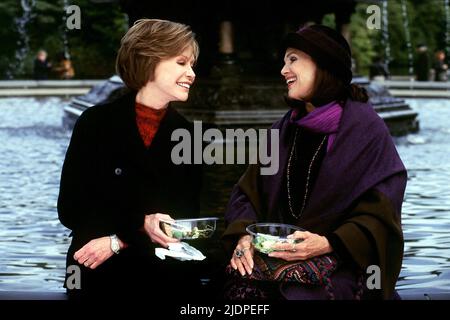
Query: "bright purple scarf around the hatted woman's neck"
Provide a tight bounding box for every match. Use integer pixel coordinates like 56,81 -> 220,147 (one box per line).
289,101 -> 342,152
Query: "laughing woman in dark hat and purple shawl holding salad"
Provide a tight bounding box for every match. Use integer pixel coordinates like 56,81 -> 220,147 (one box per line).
223,25 -> 407,299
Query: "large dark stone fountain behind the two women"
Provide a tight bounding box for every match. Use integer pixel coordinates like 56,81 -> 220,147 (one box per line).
65,0 -> 419,136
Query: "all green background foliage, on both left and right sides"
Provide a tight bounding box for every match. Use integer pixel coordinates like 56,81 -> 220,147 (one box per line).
0,0 -> 447,78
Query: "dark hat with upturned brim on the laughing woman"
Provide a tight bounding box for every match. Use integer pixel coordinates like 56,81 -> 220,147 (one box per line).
282,25 -> 353,84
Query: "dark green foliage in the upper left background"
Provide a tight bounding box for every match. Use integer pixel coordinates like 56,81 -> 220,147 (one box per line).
0,0 -> 128,79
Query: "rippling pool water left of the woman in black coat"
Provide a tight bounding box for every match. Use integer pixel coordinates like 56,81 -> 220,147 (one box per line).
0,98 -> 68,291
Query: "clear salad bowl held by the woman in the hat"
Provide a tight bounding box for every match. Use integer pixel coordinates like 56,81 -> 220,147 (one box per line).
246,223 -> 305,254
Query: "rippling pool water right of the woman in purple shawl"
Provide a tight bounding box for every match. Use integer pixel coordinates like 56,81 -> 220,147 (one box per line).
396,99 -> 450,293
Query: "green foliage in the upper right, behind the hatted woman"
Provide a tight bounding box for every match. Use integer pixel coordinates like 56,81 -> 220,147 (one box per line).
351,0 -> 446,75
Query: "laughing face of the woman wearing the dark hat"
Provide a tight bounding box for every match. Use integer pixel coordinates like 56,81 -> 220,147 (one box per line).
281,48 -> 317,101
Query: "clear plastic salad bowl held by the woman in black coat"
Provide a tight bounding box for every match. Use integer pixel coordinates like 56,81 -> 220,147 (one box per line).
161,217 -> 219,240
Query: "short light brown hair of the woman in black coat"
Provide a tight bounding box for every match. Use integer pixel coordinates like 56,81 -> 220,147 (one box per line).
116,19 -> 200,90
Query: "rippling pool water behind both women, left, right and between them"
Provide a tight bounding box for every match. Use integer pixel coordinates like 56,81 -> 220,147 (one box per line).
0,98 -> 450,293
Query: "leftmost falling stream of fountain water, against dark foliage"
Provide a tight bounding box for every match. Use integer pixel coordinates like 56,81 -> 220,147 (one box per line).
6,0 -> 35,79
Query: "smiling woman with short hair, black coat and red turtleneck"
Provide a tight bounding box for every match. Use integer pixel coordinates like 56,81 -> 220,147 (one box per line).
58,19 -> 201,295
